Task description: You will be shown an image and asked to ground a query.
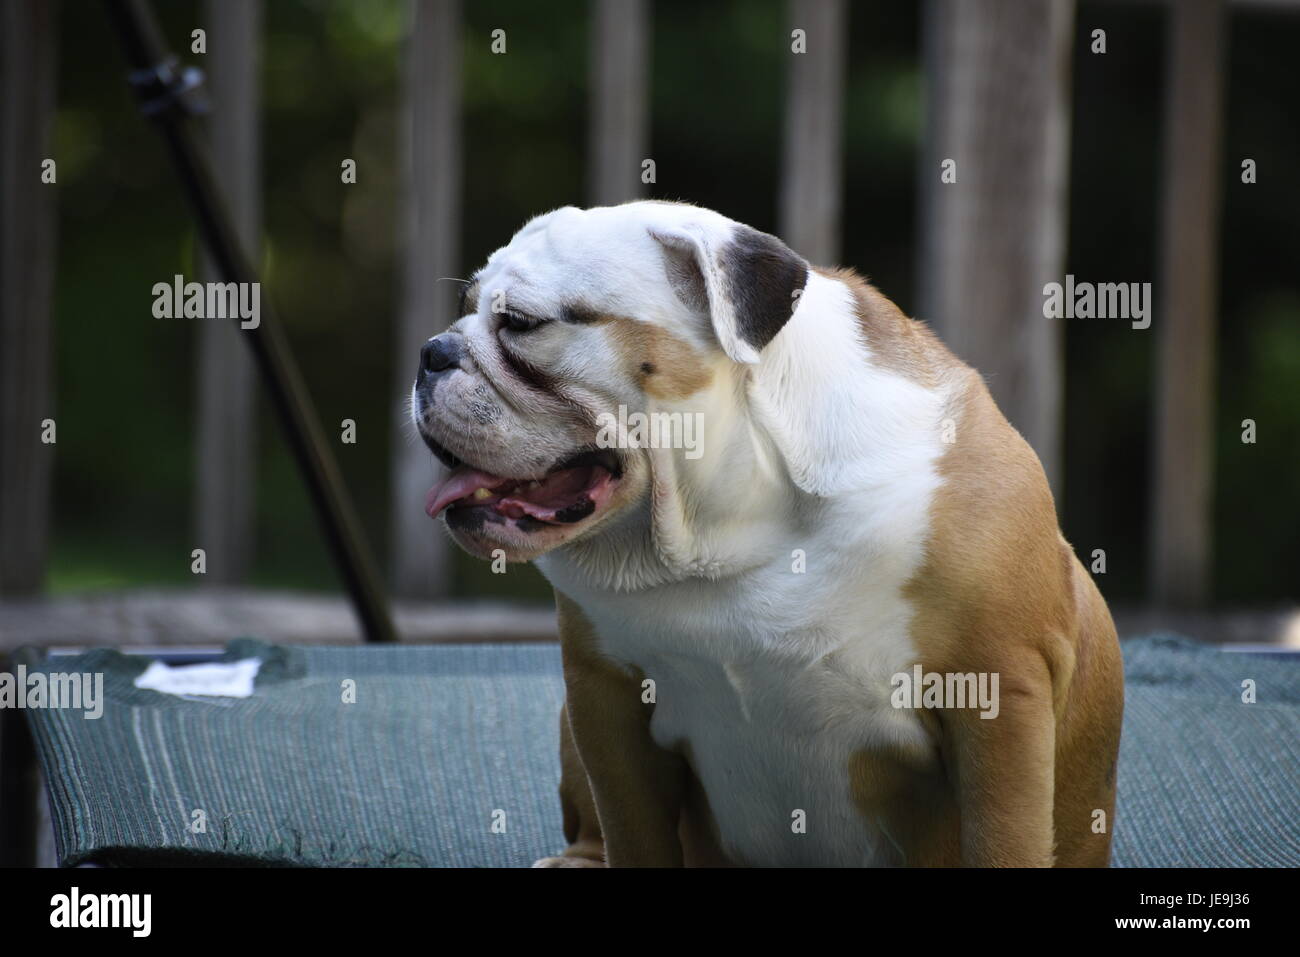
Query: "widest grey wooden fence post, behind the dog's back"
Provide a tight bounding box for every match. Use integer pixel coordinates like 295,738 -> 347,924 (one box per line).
920,0 -> 1074,494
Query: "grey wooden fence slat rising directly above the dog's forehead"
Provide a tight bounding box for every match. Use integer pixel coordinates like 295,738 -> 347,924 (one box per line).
588,0 -> 650,205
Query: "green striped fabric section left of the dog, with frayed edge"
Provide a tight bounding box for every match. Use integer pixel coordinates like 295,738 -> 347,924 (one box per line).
29,640 -> 563,866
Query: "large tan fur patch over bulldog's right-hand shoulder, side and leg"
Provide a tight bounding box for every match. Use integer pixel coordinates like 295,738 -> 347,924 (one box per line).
883,350 -> 1123,866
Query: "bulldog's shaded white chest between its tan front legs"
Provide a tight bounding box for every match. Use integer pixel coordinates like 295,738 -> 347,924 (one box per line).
579,572 -> 933,866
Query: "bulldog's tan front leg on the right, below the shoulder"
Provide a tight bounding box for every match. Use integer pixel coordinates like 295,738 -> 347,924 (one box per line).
945,660 -> 1056,867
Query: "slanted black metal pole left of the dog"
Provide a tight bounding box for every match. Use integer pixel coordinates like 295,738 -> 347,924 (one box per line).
105,0 -> 397,641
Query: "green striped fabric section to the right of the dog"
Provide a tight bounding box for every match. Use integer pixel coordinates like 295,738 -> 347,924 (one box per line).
1112,636 -> 1300,867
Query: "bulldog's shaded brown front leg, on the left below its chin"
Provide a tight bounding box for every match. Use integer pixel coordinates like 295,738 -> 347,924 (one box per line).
555,592 -> 685,867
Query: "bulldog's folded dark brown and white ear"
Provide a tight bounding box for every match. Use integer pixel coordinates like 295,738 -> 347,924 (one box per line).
650,224 -> 809,363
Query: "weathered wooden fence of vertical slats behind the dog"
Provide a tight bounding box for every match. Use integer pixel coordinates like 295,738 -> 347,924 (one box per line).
0,0 -> 1258,607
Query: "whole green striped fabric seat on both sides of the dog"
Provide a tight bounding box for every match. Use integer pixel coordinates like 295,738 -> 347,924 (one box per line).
20,637 -> 1300,867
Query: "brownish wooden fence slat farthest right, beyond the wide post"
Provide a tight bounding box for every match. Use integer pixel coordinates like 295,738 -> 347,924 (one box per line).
1151,0 -> 1226,609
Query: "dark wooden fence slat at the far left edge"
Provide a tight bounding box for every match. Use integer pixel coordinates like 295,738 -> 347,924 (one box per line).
0,0 -> 59,594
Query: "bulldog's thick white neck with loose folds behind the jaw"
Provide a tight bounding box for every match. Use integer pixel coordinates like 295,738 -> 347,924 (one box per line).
538,273 -> 943,592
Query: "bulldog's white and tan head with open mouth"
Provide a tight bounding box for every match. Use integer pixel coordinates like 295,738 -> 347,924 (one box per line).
411,202 -> 809,572
